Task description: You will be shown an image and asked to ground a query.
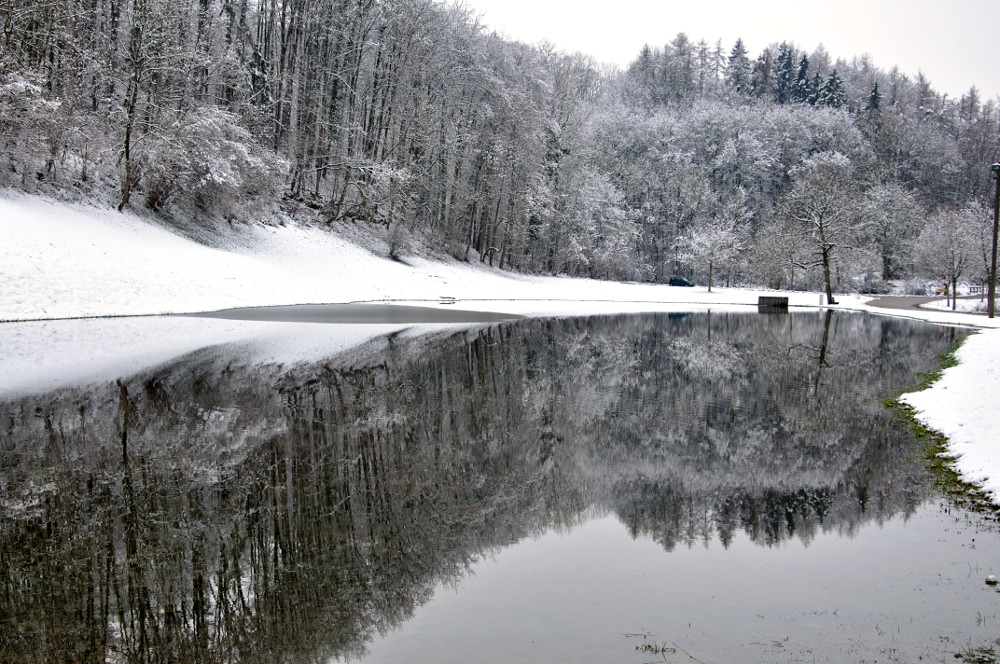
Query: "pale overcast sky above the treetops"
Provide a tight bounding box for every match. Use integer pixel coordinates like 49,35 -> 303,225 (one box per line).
465,0 -> 1000,99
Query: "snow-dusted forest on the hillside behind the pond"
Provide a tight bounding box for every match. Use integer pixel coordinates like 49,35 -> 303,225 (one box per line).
0,0 -> 1000,298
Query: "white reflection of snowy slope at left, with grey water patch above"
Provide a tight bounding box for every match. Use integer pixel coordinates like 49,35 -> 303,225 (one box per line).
0,303 -> 522,400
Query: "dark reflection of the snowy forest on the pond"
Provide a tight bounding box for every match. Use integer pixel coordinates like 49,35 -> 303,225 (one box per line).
0,313 -> 960,662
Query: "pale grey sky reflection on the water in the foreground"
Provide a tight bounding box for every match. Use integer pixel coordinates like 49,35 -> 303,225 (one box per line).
365,505 -> 1000,663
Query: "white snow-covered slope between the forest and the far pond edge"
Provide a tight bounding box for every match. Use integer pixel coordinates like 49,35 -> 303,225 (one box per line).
0,192 -> 868,321
